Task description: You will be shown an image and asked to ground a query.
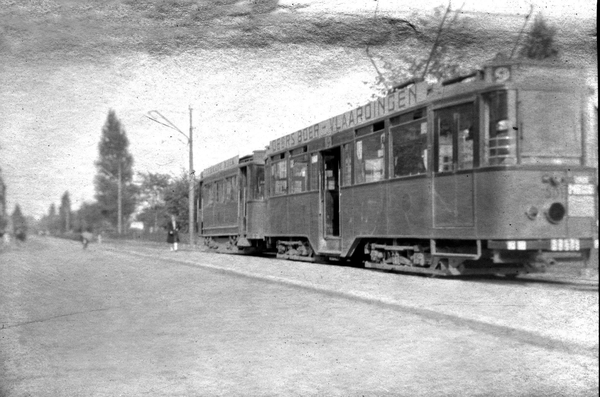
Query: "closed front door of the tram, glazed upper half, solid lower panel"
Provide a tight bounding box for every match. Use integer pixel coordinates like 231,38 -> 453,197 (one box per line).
433,102 -> 478,228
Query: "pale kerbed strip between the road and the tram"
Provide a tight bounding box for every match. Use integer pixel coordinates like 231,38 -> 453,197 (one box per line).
101,238 -> 598,357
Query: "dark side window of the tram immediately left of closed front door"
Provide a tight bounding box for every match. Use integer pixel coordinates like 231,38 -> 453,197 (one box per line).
390,109 -> 427,177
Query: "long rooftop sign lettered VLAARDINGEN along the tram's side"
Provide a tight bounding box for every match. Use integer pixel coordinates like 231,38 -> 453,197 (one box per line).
267,83 -> 427,154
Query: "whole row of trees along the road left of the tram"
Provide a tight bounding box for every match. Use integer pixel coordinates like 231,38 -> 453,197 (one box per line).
40,110 -> 195,234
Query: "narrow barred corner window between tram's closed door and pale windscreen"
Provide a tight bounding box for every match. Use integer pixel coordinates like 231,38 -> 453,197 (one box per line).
483,91 -> 517,165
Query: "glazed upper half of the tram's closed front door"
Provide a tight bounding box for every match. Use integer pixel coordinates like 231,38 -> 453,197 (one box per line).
435,103 -> 477,172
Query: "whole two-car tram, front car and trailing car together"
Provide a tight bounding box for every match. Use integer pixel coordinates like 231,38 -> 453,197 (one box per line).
199,60 -> 598,276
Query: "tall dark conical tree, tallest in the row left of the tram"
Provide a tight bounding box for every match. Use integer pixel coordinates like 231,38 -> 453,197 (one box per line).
95,109 -> 137,233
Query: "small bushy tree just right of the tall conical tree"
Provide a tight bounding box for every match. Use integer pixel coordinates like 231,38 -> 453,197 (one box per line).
137,172 -> 171,230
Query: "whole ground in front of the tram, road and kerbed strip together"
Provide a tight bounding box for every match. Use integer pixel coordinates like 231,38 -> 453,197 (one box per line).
0,238 -> 598,397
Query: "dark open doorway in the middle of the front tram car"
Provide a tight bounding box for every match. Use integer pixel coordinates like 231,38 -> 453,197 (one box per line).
321,147 -> 340,238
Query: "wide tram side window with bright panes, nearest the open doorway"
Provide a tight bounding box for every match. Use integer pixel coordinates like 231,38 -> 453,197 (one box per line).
354,134 -> 385,183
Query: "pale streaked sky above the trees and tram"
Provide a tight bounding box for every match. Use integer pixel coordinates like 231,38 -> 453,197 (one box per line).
0,0 -> 596,217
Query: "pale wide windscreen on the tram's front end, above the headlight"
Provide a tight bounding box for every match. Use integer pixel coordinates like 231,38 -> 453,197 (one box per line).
519,91 -> 583,164
